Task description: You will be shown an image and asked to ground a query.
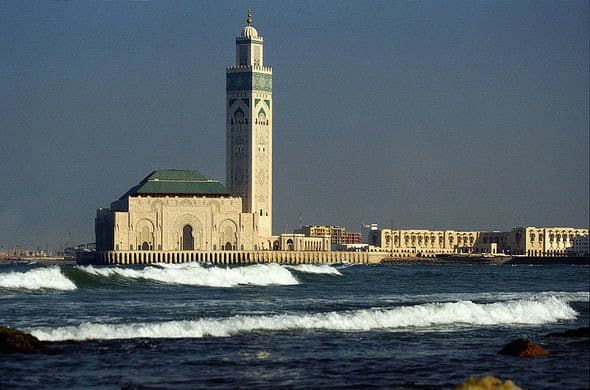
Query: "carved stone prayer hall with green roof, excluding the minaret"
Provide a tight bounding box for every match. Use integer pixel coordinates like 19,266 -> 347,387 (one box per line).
96,170 -> 275,251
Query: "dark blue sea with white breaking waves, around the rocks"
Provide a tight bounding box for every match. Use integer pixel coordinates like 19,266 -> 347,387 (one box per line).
0,262 -> 590,389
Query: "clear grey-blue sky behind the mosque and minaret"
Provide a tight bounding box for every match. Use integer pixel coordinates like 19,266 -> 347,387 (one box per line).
0,0 -> 590,249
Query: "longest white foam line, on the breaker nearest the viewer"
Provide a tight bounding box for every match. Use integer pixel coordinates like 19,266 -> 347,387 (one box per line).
30,297 -> 577,341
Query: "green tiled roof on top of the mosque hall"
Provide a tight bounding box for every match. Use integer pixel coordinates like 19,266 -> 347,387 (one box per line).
121,169 -> 230,198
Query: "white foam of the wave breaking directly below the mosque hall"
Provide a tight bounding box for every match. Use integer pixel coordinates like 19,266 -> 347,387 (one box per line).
78,263 -> 299,287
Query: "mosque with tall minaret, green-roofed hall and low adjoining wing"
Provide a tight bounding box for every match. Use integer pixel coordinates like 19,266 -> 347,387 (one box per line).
95,12 -> 354,264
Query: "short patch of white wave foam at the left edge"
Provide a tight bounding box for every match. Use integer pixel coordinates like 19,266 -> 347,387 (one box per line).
0,267 -> 76,291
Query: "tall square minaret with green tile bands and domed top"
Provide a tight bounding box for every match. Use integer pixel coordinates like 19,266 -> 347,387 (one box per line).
226,10 -> 272,237
